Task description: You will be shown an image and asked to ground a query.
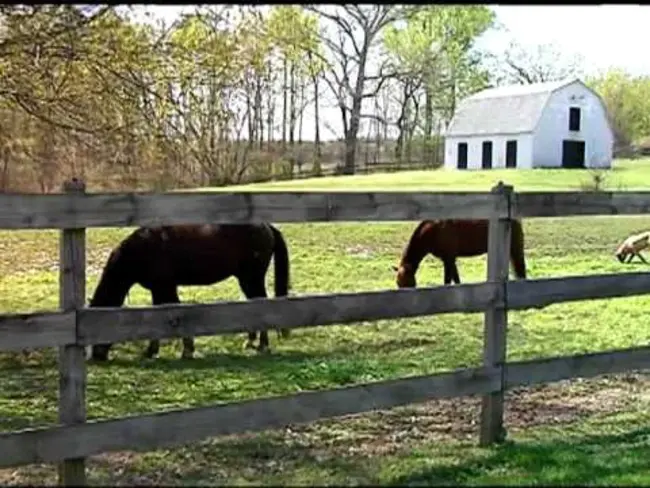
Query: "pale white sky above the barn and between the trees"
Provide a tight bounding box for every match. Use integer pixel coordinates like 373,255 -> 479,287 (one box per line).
132,5 -> 650,140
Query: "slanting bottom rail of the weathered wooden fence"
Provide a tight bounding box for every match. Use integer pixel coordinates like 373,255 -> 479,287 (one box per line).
0,347 -> 650,467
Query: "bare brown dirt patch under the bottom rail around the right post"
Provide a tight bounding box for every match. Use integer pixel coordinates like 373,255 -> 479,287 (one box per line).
270,373 -> 650,456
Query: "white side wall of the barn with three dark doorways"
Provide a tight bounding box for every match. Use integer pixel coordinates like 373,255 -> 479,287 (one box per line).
445,134 -> 533,169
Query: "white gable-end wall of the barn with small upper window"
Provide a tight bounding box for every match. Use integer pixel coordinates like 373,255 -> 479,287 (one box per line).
533,82 -> 614,168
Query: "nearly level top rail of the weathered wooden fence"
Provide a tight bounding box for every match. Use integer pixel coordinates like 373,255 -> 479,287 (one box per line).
0,192 -> 650,229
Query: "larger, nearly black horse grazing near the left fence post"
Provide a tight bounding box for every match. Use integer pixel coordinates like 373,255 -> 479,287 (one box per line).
90,224 -> 289,361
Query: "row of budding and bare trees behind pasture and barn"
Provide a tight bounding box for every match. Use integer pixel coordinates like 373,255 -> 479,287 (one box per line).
0,5 -> 650,192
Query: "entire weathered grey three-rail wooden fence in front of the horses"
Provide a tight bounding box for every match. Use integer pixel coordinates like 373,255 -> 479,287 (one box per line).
0,181 -> 650,485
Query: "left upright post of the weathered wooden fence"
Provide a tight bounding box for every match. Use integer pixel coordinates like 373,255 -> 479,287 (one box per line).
59,178 -> 86,486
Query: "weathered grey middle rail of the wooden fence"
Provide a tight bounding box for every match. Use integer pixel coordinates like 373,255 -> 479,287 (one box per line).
0,272 -> 650,351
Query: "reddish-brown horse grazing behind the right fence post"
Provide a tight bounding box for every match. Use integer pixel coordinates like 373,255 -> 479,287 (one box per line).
393,219 -> 526,288
